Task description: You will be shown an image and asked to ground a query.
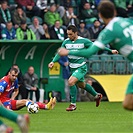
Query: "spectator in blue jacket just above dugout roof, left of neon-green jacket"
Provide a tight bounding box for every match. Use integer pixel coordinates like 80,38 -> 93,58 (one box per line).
1,22 -> 16,40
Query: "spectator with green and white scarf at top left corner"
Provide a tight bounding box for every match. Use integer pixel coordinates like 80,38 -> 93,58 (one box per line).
0,0 -> 12,27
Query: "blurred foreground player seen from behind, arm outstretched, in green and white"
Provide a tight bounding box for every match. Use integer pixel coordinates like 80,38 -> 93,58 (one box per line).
58,0 -> 133,110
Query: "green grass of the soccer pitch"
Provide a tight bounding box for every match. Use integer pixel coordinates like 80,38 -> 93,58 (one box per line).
2,102 -> 133,133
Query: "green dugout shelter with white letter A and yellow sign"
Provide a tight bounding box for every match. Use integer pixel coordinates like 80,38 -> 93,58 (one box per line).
0,40 -> 65,99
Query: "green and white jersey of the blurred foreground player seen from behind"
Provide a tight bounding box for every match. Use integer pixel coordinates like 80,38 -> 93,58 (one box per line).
94,17 -> 133,61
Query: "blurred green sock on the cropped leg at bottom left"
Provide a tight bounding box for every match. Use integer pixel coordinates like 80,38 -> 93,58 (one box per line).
0,105 -> 18,122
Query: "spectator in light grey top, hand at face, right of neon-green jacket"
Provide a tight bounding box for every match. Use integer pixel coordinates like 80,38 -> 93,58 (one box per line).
29,17 -> 44,40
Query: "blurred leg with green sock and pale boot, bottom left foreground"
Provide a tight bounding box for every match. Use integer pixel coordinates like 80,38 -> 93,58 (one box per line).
0,104 -> 29,133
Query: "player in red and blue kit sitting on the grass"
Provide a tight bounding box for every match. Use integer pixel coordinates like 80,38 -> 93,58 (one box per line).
0,68 -> 56,110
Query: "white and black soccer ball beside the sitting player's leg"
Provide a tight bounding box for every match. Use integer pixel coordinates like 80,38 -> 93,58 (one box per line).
27,103 -> 39,114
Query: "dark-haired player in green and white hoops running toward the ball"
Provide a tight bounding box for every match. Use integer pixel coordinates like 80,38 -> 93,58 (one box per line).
48,25 -> 116,111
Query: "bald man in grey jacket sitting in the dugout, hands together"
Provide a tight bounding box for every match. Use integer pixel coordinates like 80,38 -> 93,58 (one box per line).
24,66 -> 40,101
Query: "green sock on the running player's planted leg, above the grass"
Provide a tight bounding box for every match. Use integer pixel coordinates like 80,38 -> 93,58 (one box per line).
70,85 -> 77,103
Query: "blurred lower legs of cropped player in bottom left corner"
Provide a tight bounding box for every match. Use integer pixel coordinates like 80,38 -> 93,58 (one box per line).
0,102 -> 29,133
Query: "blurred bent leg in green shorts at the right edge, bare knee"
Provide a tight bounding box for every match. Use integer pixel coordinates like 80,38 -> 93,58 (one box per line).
123,76 -> 133,110
